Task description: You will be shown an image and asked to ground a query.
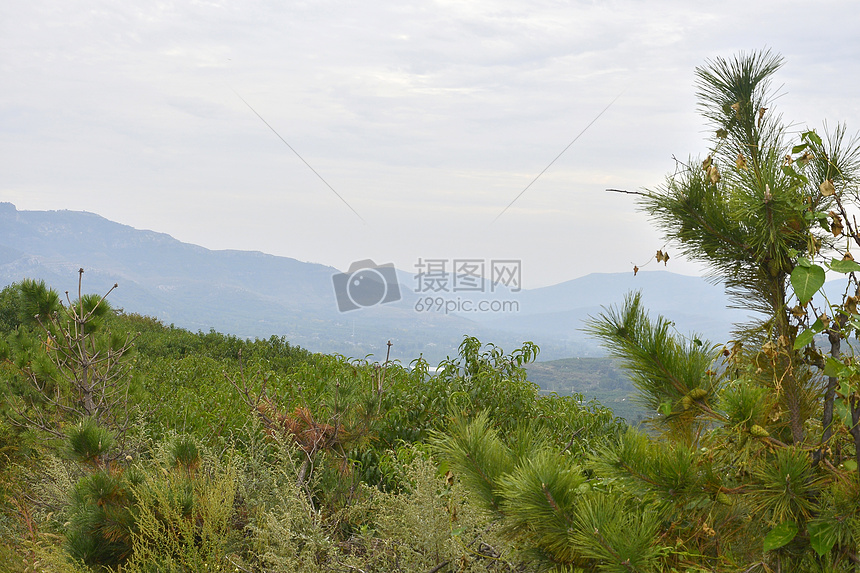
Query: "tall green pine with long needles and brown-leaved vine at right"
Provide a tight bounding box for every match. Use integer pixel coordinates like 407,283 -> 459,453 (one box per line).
439,52 -> 860,572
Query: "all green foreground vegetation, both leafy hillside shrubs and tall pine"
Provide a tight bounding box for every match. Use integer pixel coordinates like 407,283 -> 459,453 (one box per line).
5,52 -> 860,573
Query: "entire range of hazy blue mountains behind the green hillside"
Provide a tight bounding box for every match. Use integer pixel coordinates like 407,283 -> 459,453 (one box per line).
0,203 -> 745,363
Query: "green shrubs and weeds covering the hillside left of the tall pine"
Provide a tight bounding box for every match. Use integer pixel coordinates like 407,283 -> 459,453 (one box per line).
0,274 -> 621,571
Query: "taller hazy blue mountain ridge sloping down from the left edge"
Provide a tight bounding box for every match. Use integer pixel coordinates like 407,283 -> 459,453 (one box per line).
0,203 -> 498,361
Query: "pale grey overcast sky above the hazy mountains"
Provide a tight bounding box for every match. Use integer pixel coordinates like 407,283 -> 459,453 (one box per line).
0,0 -> 860,288
